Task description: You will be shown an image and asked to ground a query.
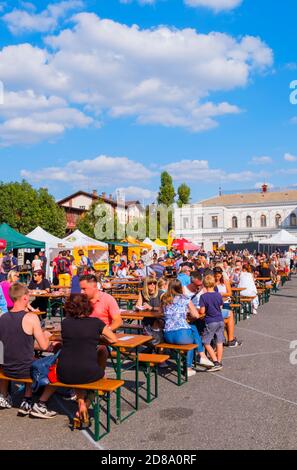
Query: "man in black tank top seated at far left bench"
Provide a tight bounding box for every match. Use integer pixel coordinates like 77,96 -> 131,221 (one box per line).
0,283 -> 57,418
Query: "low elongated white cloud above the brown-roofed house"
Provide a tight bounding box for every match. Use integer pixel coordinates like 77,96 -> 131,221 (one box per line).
21,155 -> 154,185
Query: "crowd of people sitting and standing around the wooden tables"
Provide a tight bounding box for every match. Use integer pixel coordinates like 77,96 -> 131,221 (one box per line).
0,246 -> 297,423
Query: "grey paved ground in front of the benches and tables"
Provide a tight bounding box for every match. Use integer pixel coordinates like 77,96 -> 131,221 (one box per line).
0,278 -> 297,450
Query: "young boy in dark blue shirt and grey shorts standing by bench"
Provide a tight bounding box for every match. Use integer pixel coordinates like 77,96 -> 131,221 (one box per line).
199,275 -> 224,372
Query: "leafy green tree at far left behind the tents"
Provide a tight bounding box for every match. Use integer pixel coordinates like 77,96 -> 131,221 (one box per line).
0,180 -> 66,237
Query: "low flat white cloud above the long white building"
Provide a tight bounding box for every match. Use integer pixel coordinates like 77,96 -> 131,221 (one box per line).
163,160 -> 266,183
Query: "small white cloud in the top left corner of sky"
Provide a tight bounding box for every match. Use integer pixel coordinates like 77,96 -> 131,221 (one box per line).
2,0 -> 84,34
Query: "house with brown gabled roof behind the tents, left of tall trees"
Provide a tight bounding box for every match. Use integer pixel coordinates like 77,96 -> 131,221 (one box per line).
57,190 -> 143,232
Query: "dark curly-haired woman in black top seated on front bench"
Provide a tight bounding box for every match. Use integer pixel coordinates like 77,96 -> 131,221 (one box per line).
57,294 -> 117,424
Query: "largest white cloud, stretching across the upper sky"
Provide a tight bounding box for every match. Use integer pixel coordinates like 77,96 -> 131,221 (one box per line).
0,13 -> 273,145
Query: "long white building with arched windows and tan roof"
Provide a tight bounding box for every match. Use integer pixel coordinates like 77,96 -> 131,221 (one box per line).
174,185 -> 297,251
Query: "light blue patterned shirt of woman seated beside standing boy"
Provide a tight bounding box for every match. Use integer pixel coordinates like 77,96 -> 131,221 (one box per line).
164,295 -> 191,331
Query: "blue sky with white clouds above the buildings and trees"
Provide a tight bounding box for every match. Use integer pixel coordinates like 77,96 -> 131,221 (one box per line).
0,0 -> 297,202
